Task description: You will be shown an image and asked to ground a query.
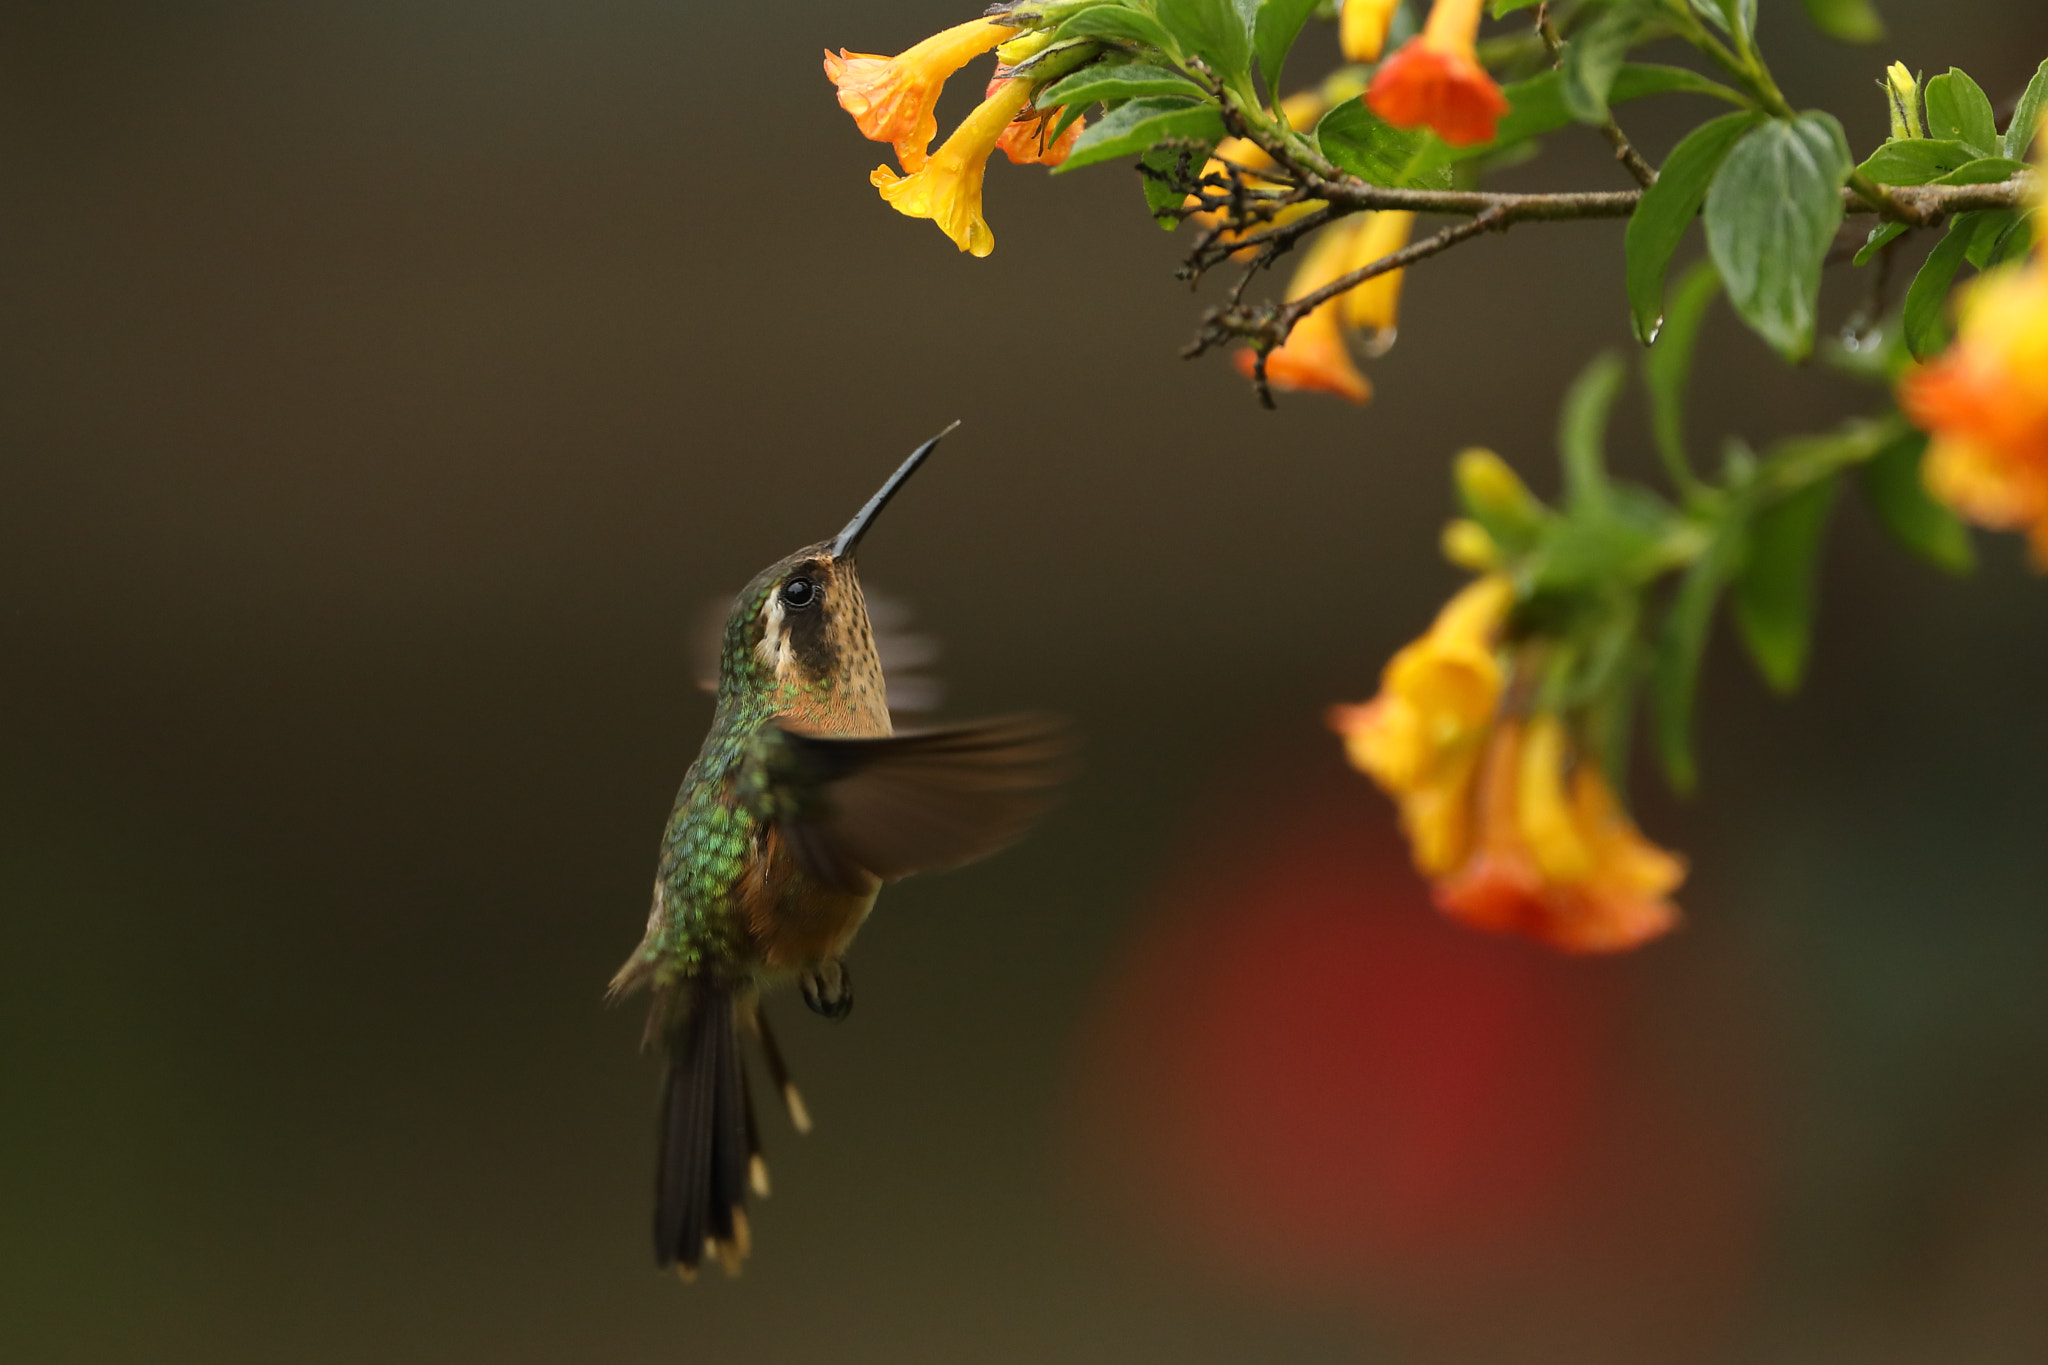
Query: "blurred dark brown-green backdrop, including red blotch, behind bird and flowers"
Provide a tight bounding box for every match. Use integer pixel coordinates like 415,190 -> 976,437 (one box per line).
0,0 -> 2048,1365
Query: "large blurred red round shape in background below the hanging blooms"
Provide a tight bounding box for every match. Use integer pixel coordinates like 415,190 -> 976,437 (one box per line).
1069,782 -> 1765,1345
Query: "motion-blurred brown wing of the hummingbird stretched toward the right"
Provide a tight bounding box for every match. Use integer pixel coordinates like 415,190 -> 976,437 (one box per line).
741,716 -> 1071,892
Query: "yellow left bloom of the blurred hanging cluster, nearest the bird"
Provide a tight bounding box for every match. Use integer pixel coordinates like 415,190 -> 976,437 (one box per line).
1329,573 -> 1516,878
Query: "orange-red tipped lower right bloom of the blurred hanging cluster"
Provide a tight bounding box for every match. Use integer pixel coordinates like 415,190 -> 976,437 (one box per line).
1436,714 -> 1686,954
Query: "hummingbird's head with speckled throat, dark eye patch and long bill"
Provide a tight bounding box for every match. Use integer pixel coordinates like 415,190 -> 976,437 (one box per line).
719,424 -> 958,733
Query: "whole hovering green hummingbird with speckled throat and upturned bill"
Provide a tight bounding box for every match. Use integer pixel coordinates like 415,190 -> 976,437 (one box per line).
610,422 -> 1067,1281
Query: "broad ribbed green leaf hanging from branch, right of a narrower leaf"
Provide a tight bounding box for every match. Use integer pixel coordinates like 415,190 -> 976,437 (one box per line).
1706,111 -> 1849,360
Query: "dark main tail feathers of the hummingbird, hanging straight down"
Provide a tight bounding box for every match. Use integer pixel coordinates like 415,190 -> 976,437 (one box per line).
653,982 -> 754,1279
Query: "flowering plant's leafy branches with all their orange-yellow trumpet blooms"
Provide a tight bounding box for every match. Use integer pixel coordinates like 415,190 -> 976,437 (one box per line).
825,0 -> 2048,952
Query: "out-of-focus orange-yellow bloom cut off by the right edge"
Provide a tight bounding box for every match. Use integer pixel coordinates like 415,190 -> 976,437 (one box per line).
1898,172 -> 2048,571
